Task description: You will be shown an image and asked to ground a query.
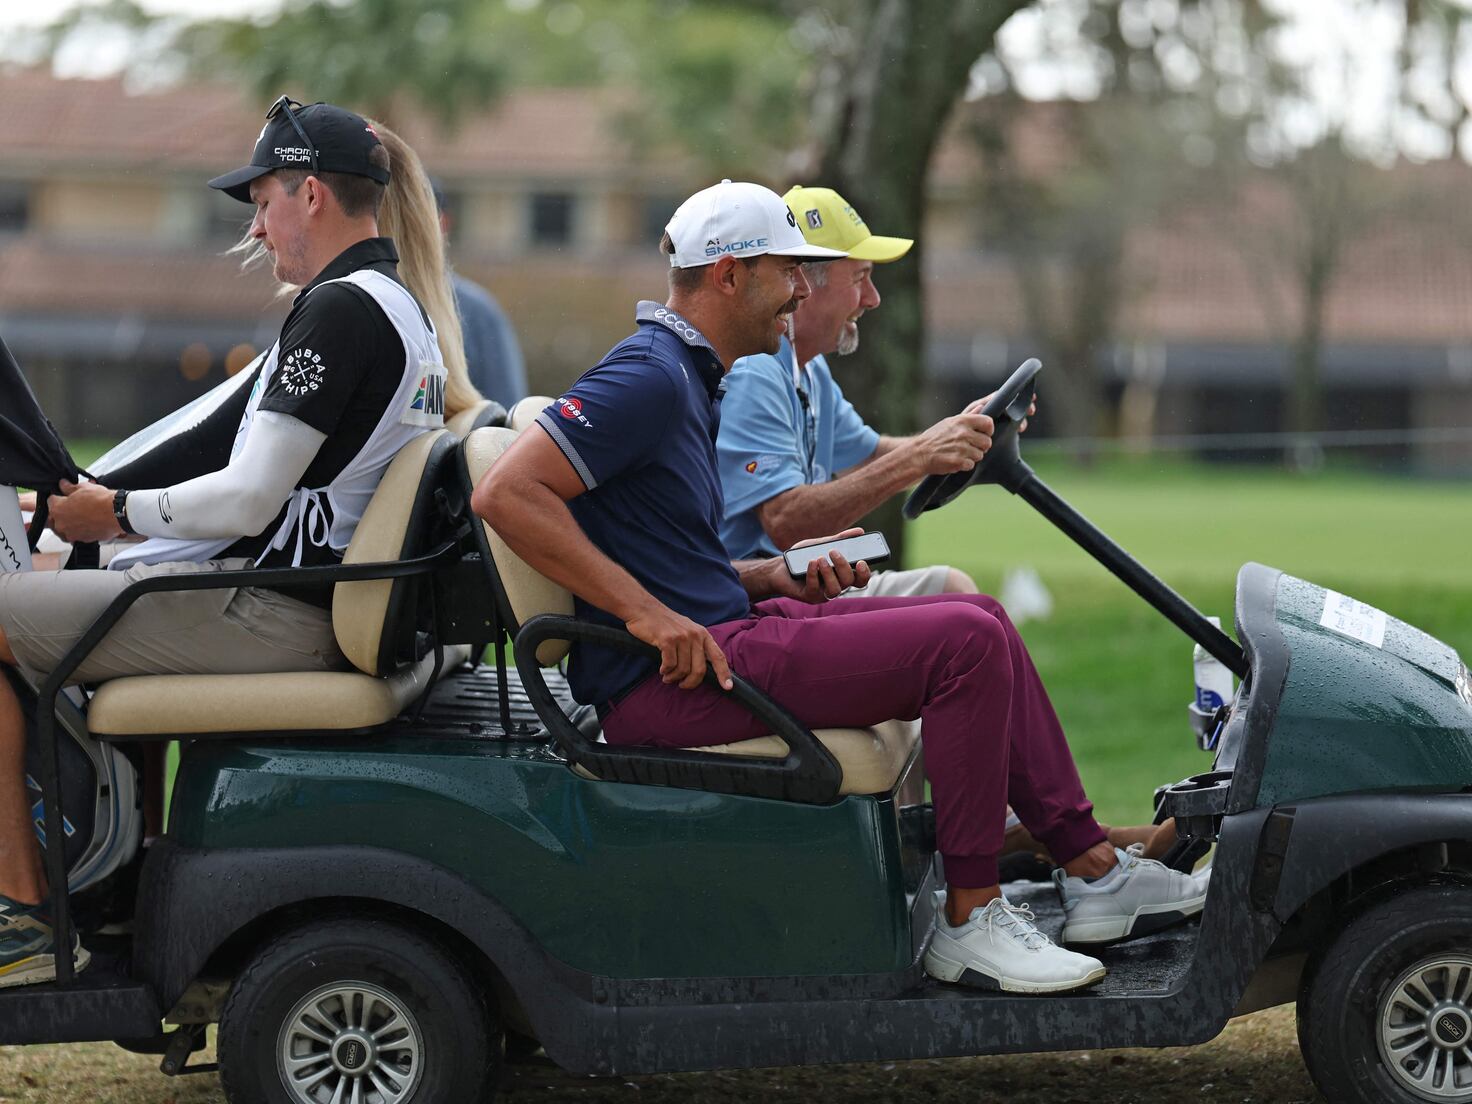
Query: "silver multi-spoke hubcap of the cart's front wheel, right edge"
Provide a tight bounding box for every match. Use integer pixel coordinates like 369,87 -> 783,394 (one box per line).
1378,955 -> 1472,1101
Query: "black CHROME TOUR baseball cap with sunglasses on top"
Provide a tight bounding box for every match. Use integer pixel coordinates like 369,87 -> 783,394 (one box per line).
209,96 -> 389,203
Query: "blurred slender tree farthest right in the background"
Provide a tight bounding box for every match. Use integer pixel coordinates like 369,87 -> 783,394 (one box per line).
1225,0 -> 1472,467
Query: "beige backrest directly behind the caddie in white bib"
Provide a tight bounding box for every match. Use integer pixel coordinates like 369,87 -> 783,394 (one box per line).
333,430 -> 455,676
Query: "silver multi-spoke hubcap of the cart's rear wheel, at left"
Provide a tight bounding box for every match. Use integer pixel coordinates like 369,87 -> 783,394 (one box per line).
277,982 -> 424,1104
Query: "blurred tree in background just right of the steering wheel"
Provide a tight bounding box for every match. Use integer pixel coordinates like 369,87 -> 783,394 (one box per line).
967,0 -> 1270,461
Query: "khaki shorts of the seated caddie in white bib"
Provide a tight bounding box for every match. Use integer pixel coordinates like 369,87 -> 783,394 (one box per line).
0,559 -> 347,684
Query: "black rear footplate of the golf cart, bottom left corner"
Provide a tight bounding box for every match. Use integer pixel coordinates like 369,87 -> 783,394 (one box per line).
0,949 -> 163,1045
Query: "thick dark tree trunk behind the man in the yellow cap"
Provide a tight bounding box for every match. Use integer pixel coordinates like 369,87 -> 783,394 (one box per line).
802,0 -> 1026,561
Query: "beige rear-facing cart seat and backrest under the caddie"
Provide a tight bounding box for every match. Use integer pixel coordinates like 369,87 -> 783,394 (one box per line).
87,430 -> 468,737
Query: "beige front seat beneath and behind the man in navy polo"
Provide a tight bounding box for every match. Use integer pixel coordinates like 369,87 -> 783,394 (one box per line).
462,426 -> 920,793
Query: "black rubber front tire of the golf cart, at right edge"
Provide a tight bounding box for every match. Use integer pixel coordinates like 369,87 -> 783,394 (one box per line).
1298,883 -> 1472,1104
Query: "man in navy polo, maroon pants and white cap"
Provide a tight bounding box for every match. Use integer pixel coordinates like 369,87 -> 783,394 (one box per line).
471,181 -> 1206,992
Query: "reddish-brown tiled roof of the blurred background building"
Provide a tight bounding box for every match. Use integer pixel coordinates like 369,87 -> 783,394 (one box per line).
0,71 -> 1472,361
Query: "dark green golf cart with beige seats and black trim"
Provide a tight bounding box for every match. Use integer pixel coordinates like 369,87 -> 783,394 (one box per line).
0,362 -> 1472,1104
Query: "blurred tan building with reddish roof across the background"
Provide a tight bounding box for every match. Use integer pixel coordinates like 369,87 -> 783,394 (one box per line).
0,71 -> 1472,468
